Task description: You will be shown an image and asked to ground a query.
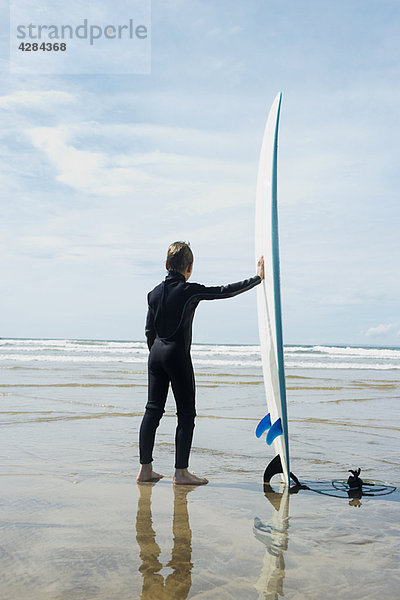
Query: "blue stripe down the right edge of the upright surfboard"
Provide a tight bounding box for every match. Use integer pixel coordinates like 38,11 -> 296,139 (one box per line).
267,95 -> 290,473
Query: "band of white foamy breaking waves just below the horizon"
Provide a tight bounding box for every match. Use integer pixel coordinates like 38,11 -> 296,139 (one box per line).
0,339 -> 400,370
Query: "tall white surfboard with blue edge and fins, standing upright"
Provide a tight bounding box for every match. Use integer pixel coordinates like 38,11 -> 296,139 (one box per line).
255,93 -> 290,485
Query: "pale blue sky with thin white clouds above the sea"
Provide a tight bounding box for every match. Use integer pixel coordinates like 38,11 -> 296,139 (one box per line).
0,0 -> 400,346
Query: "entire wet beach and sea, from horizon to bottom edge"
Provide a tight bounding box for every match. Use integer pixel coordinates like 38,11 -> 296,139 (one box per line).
0,339 -> 400,600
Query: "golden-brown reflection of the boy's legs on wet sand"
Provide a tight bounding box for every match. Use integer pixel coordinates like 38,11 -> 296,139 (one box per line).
136,483 -> 193,600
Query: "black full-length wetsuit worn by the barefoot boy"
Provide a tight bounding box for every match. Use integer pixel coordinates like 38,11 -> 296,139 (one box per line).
139,271 -> 261,469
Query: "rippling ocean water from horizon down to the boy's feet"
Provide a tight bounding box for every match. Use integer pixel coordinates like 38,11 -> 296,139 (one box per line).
0,339 -> 400,480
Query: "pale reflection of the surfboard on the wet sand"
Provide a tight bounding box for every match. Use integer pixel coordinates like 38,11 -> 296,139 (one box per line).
253,485 -> 289,600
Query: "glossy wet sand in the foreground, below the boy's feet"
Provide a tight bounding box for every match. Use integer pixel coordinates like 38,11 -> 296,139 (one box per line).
0,474 -> 400,600
